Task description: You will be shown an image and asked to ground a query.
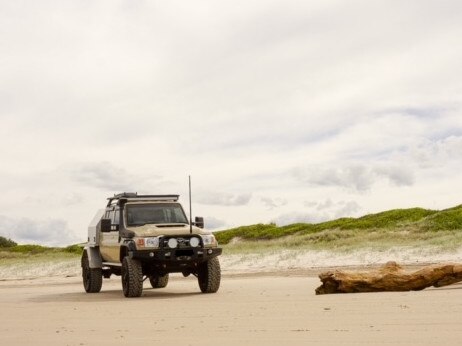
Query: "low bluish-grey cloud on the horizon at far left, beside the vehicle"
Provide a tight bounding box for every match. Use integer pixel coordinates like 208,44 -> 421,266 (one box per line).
0,216 -> 79,246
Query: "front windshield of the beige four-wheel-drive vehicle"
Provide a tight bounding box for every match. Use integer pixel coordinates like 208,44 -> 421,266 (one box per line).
126,203 -> 188,226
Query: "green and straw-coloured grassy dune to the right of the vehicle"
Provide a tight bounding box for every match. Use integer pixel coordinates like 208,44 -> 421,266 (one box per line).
215,206 -> 462,253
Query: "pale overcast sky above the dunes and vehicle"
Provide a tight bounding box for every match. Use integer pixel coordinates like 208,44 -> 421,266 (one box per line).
0,0 -> 462,245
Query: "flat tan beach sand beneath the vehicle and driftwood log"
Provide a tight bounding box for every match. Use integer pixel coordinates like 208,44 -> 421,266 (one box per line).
0,270 -> 462,345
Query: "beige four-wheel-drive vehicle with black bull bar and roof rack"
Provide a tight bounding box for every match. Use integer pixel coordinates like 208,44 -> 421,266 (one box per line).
82,192 -> 222,297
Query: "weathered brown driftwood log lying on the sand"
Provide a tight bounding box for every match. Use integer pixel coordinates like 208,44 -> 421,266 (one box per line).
316,262 -> 462,294
